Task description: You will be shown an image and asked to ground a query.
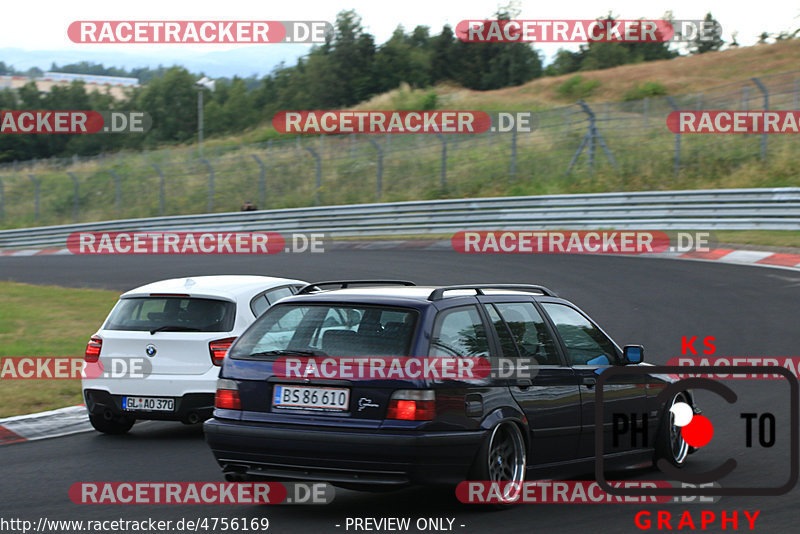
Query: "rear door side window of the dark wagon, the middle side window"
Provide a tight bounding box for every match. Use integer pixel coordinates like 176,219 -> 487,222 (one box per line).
490,302 -> 561,365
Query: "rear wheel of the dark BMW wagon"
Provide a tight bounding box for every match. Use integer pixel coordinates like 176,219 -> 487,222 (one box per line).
470,421 -> 527,508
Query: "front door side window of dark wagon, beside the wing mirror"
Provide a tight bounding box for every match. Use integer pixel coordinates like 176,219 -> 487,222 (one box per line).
542,303 -> 618,365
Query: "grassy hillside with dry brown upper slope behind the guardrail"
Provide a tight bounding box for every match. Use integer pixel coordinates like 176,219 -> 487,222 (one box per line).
0,40 -> 800,244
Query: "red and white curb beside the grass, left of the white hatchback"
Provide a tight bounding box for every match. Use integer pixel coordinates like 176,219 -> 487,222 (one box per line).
0,406 -> 92,445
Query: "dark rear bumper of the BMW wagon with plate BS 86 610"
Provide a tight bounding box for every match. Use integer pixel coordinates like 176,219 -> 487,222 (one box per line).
203,419 -> 487,486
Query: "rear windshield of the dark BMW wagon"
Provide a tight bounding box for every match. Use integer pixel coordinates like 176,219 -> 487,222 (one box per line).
230,304 -> 418,359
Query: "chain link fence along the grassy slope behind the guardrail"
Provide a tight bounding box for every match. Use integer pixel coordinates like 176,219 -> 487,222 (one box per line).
0,71 -> 800,228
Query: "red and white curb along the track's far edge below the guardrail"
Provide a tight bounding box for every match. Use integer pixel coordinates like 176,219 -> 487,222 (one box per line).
0,243 -> 800,270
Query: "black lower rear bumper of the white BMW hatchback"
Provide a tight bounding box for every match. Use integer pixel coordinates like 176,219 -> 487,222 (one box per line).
83,389 -> 214,423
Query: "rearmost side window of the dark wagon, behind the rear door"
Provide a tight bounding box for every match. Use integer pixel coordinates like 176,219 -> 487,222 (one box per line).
428,306 -> 489,358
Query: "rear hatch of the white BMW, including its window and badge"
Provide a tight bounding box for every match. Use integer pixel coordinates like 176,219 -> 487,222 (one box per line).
100,295 -> 236,375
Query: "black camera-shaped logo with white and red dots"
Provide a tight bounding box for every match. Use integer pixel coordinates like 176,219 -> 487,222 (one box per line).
594,365 -> 800,496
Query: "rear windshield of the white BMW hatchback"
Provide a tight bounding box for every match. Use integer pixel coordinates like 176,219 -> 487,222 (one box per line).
103,297 -> 236,332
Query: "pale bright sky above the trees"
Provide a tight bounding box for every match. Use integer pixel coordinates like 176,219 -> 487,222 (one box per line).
0,0 -> 800,76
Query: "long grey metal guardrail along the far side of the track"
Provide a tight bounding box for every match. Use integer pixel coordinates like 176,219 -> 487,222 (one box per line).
0,187 -> 800,249
